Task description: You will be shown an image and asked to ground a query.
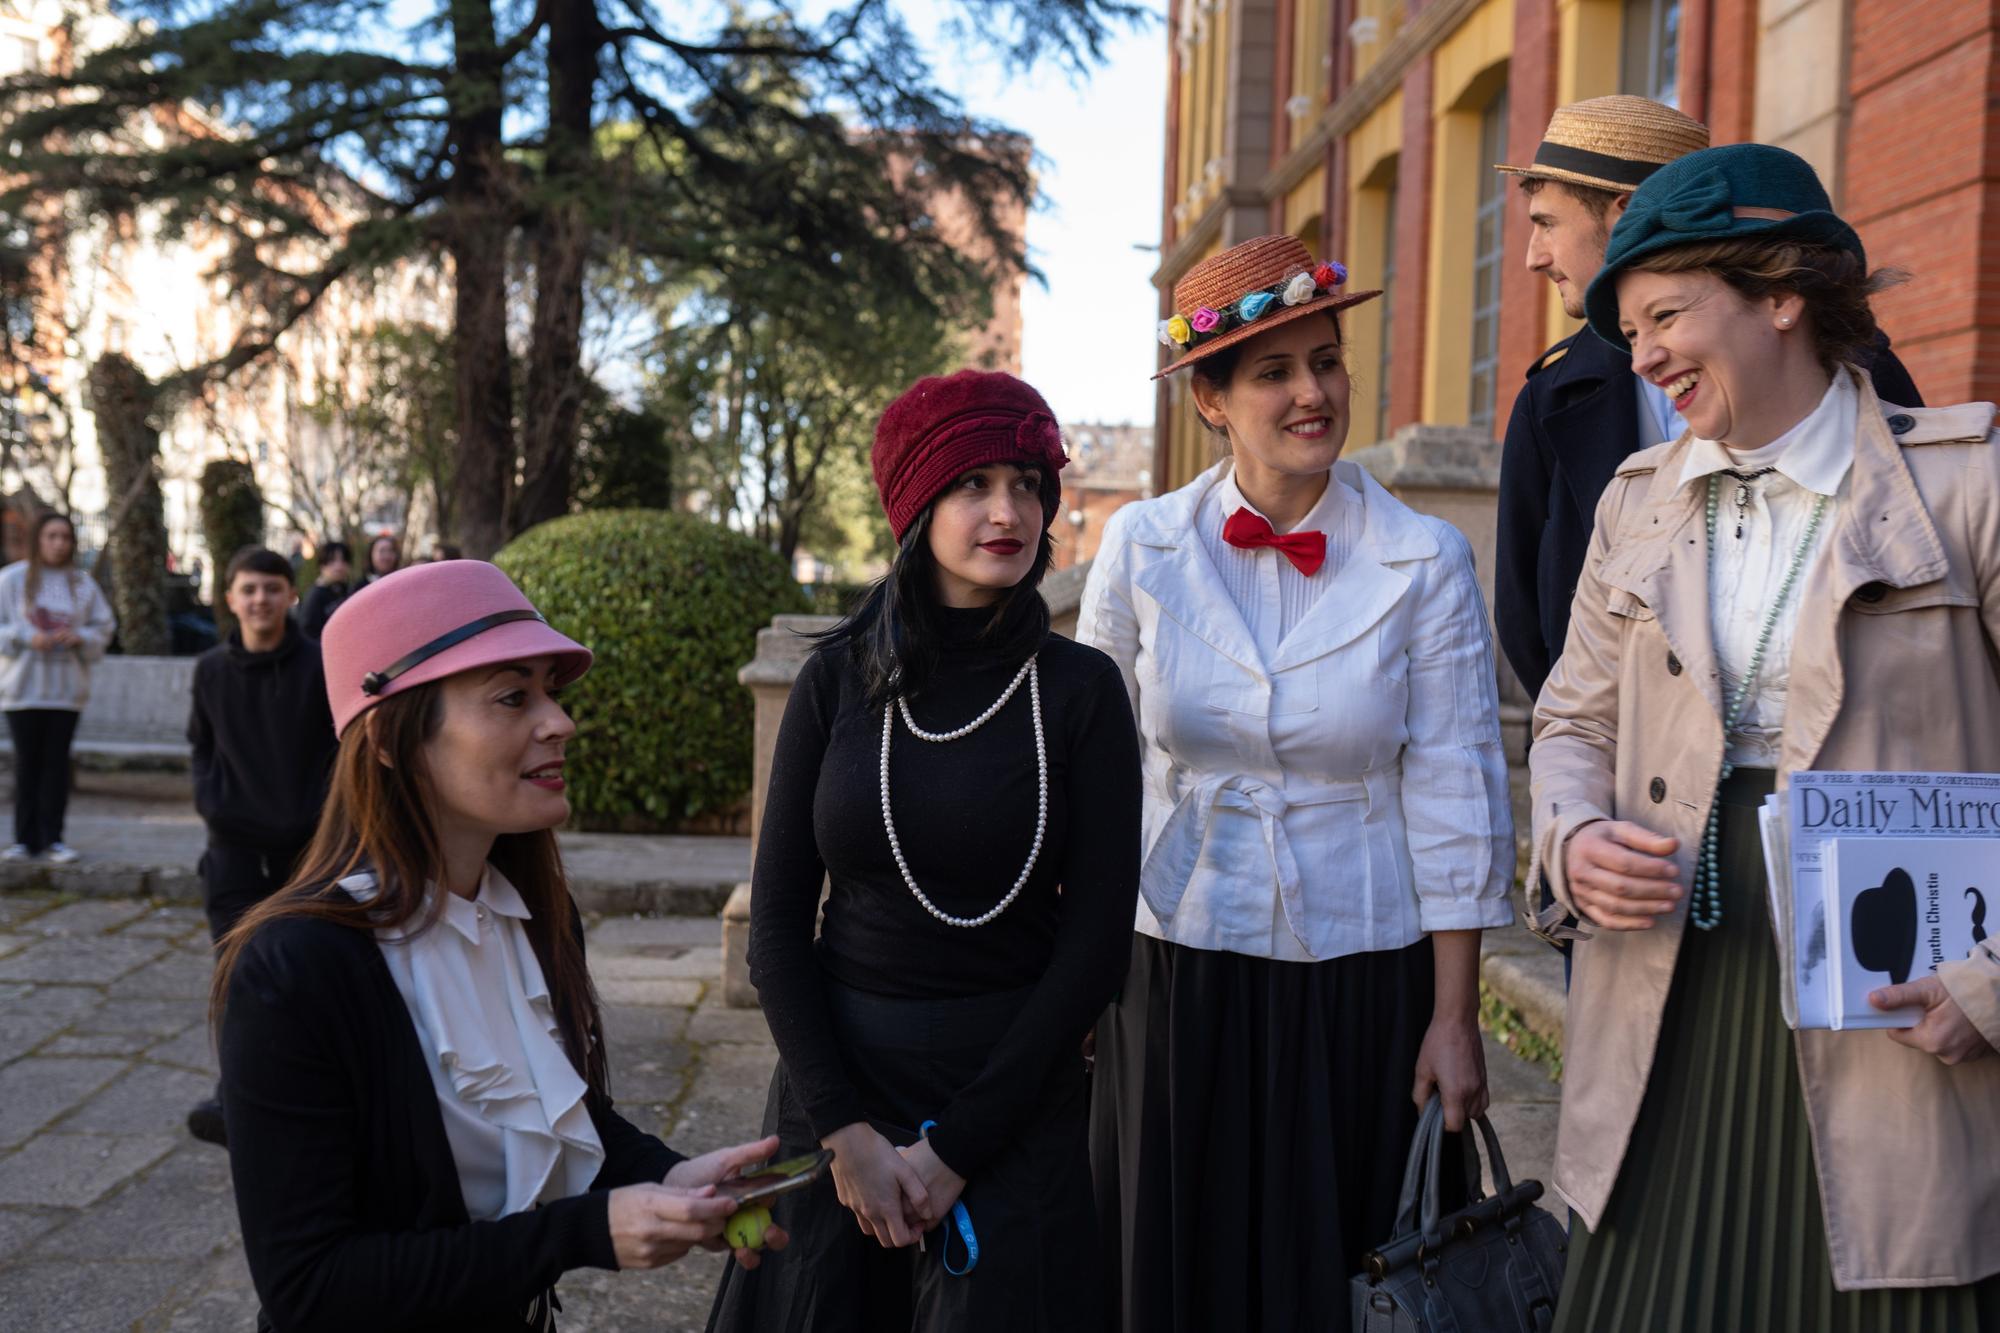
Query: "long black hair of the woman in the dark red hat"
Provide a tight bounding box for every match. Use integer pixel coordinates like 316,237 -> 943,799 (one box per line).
814,472 -> 1056,709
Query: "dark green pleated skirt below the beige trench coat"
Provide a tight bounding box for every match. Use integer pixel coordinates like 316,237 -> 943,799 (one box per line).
1556,769 -> 2000,1333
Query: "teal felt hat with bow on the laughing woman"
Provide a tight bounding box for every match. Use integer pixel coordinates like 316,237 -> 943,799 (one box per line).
1584,144 -> 1868,346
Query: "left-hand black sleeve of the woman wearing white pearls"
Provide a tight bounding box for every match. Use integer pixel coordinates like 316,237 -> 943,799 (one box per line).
750,652 -> 866,1139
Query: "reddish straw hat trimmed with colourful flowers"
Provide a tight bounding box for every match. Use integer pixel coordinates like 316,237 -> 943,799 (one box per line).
1152,236 -> 1382,380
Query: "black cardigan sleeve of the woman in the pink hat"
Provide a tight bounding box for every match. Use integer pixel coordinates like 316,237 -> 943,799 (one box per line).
218,921 -> 618,1333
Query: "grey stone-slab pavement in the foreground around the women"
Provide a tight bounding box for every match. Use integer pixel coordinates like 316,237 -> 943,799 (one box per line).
0,893 -> 1556,1333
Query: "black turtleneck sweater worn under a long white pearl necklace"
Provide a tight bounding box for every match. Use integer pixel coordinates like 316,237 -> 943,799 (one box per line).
750,610 -> 1140,1177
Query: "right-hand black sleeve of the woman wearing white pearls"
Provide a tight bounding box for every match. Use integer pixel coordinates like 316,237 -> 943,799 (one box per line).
930,650 -> 1140,1177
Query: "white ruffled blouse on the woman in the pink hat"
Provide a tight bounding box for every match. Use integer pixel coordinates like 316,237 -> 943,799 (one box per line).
340,867 -> 604,1221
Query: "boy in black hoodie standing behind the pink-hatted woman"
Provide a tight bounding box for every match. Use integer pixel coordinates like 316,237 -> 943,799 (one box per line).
188,546 -> 336,1143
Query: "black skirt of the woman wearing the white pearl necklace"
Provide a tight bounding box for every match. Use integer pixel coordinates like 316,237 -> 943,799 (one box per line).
708,981 -> 1108,1333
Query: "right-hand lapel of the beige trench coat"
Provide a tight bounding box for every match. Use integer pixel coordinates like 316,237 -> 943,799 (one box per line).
1784,374 -> 1950,769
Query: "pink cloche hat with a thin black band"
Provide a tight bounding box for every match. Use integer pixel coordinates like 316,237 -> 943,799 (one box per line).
320,560 -> 590,737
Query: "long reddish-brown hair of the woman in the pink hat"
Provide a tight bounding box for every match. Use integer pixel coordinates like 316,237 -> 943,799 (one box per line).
208,681 -> 608,1093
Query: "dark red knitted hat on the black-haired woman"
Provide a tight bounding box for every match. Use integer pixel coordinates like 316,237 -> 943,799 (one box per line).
872,370 -> 1068,542
